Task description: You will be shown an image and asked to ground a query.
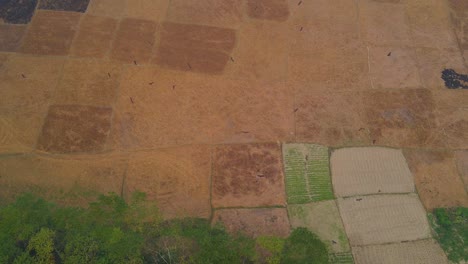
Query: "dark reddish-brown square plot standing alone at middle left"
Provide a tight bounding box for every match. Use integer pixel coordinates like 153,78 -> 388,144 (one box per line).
37,105 -> 112,153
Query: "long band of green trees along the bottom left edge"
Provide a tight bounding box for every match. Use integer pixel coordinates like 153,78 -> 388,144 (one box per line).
0,193 -> 328,264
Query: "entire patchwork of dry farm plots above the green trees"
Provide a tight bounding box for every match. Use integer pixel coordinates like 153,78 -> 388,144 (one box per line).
0,0 -> 468,263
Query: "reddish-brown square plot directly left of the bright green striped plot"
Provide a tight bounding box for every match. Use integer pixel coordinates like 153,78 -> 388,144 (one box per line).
212,143 -> 286,207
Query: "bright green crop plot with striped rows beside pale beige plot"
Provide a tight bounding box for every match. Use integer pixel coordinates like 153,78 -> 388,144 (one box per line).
283,144 -> 334,204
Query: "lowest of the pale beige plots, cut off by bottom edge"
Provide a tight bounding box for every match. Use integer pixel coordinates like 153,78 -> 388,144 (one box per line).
353,239 -> 448,264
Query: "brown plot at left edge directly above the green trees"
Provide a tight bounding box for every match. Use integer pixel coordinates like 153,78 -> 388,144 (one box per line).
0,154 -> 127,206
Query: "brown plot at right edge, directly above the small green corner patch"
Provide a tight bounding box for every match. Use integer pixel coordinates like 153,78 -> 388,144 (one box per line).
405,150 -> 468,210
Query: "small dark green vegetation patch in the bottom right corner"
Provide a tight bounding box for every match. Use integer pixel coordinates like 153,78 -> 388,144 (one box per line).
428,207 -> 468,263
